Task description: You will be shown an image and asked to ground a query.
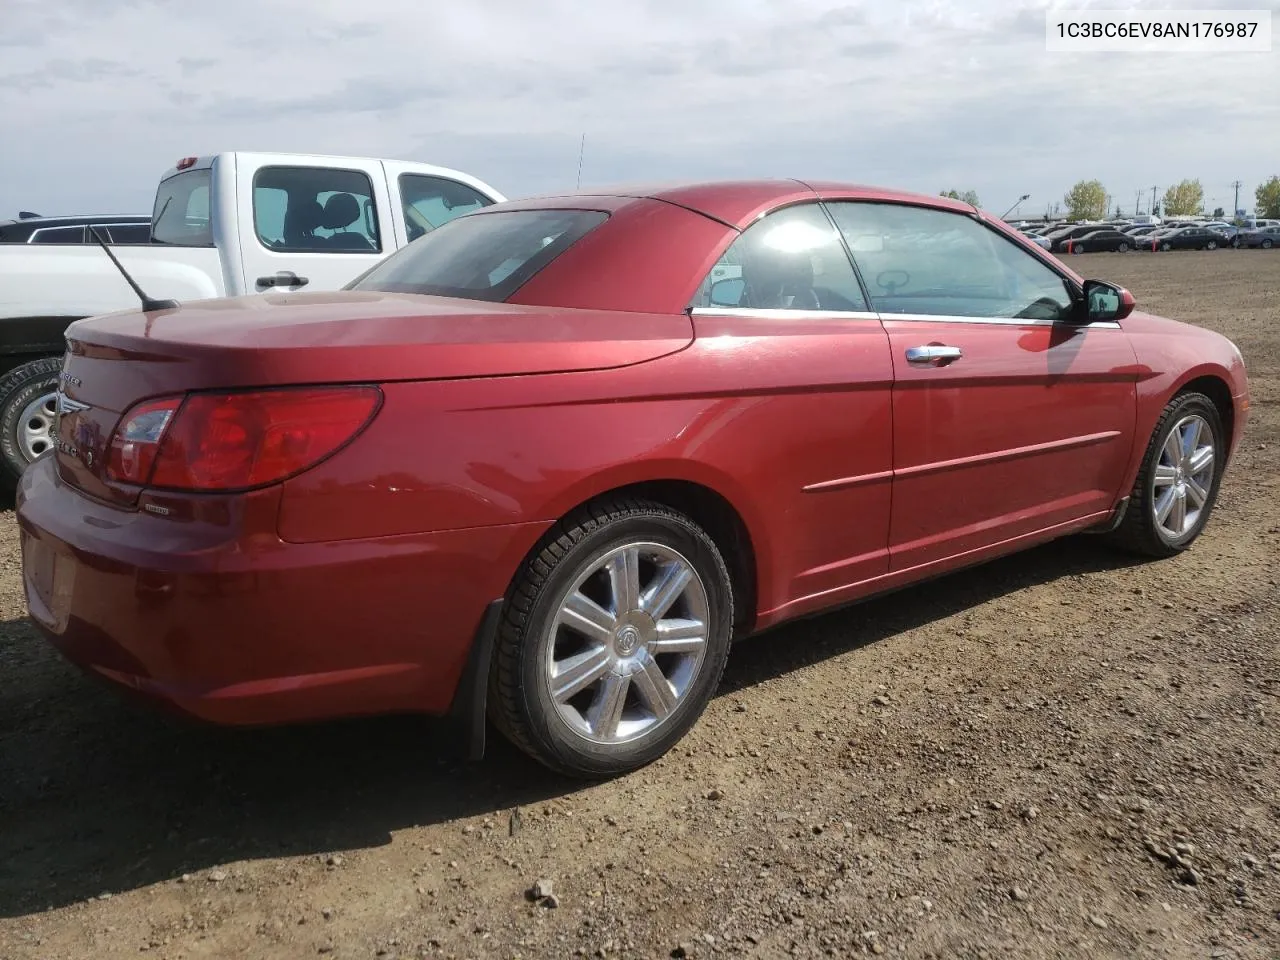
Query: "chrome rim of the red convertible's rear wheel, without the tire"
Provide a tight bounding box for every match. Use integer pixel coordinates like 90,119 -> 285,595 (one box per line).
544,543 -> 709,745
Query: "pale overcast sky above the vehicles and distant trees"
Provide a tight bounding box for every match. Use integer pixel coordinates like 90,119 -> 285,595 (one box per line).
0,0 -> 1280,218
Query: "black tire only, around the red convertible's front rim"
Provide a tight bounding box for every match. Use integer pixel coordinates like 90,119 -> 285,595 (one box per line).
1107,392 -> 1226,557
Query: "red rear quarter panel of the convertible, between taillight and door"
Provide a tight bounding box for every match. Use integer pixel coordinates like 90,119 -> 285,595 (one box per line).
279,321 -> 892,624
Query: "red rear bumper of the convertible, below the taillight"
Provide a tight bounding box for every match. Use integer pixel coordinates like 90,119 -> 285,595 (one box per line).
18,457 -> 547,724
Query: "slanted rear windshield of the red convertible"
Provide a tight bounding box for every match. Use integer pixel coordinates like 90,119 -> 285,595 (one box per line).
347,210 -> 608,301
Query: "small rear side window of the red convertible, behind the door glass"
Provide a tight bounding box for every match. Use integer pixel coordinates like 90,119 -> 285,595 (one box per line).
692,202 -> 867,311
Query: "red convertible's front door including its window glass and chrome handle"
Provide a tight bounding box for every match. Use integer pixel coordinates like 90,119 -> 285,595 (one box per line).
828,201 -> 1135,571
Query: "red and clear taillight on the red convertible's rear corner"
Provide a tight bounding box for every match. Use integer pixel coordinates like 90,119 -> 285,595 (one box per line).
108,387 -> 381,490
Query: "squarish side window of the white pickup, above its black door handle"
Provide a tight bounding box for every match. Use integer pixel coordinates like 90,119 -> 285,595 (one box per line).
253,166 -> 383,253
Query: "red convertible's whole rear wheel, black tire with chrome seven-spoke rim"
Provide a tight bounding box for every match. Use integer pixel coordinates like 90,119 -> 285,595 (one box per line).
489,499 -> 733,778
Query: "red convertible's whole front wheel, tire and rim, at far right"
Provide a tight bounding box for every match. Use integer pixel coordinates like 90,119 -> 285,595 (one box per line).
1111,393 -> 1226,557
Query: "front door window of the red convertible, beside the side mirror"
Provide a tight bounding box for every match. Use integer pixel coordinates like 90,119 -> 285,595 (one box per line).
828,201 -> 1073,320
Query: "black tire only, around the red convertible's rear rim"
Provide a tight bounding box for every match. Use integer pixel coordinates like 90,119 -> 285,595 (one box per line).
488,498 -> 733,780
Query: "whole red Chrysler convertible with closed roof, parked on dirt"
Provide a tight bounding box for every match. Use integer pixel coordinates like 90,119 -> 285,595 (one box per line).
18,180 -> 1248,777
